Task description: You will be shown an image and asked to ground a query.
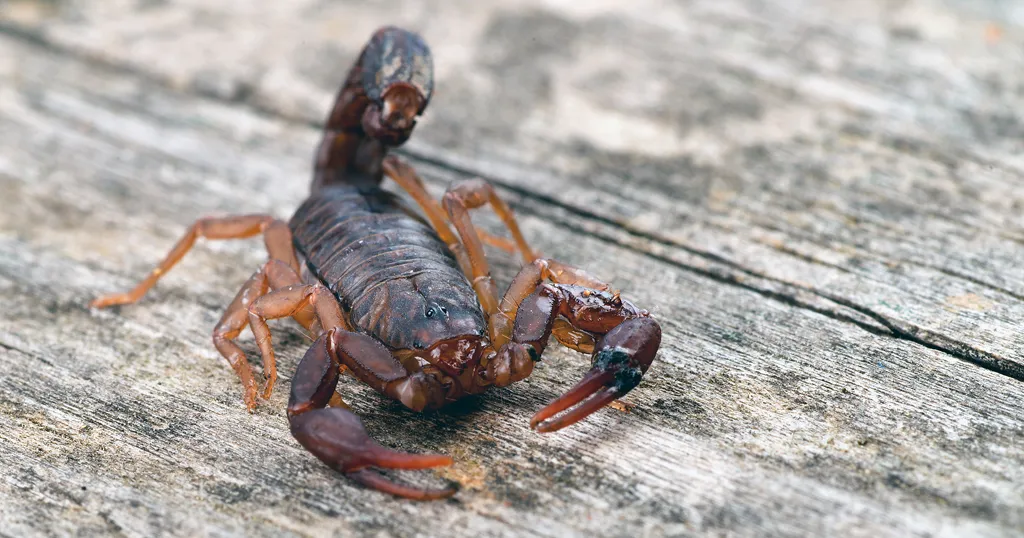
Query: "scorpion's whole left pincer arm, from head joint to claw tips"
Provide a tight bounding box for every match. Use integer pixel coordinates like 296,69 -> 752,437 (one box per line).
288,329 -> 458,500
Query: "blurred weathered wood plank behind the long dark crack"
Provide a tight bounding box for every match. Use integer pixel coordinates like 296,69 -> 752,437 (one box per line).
5,1 -> 1024,378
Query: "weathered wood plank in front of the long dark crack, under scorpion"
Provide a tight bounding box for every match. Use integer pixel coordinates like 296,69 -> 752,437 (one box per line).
0,21 -> 1024,536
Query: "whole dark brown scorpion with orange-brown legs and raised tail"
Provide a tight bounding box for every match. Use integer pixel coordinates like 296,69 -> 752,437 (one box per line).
91,27 -> 662,499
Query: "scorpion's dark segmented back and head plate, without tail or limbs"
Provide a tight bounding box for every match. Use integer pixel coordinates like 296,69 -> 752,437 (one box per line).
290,185 -> 485,348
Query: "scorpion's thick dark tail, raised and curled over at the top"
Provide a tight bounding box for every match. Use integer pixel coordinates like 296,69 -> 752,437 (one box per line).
312,27 -> 434,191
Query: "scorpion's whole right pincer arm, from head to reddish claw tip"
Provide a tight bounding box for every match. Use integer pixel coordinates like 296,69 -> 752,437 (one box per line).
486,260 -> 662,431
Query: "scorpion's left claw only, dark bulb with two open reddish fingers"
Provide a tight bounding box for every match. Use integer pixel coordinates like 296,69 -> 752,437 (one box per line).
291,407 -> 457,500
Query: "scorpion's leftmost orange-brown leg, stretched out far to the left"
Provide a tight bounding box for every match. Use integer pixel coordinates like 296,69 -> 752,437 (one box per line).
89,215 -> 299,308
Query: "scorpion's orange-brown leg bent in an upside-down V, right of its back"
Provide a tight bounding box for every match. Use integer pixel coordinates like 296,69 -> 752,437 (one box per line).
443,179 -> 537,316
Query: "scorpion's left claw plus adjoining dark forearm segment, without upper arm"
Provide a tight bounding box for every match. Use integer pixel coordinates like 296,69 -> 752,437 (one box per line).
288,331 -> 458,500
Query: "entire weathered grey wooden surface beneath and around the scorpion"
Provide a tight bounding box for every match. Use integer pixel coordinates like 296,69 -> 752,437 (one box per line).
0,0 -> 1024,536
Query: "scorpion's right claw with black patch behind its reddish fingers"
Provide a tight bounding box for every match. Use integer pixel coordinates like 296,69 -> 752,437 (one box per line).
529,318 -> 662,432
